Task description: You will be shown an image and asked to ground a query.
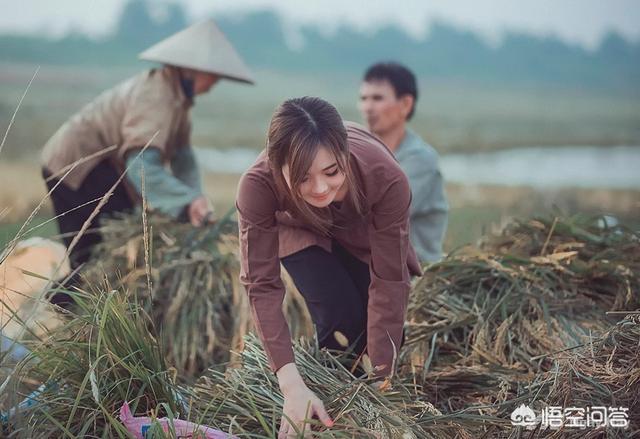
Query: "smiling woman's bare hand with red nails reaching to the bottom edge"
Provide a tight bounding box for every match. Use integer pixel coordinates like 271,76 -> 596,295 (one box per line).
277,363 -> 333,439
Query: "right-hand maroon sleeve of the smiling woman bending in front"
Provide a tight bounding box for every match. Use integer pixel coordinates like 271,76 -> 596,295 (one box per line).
367,172 -> 411,376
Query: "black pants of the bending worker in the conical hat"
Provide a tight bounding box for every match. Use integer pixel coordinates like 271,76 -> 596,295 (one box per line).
42,161 -> 133,269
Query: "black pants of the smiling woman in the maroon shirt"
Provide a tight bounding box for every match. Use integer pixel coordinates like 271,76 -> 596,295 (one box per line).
282,241 -> 371,355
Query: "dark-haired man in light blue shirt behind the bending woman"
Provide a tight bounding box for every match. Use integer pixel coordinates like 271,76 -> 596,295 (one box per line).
359,62 -> 449,262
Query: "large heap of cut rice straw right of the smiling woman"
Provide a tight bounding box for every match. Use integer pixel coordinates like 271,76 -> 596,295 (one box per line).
401,218 -> 640,410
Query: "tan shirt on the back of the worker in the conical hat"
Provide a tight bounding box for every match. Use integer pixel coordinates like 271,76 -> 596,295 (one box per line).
42,66 -> 193,189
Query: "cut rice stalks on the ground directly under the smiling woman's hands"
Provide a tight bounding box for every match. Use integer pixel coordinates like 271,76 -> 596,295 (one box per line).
190,335 -> 480,438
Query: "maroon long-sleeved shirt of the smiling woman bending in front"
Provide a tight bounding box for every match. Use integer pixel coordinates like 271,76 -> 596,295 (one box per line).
236,122 -> 420,375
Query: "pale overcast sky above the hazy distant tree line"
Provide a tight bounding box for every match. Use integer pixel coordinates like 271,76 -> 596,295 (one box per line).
0,0 -> 640,48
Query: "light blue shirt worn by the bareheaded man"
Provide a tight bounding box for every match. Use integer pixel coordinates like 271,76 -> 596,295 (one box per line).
395,128 -> 449,262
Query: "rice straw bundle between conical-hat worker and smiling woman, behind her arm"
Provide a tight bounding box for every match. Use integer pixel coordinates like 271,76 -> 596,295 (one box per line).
83,212 -> 313,377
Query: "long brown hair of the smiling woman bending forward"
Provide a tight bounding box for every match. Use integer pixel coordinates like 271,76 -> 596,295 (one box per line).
267,96 -> 363,235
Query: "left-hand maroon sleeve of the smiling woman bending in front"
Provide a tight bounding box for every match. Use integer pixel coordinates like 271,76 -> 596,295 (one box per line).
236,173 -> 294,371
